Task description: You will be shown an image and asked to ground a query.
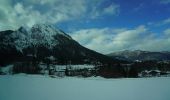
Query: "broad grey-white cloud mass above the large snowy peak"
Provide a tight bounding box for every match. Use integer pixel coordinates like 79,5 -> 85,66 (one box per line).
0,0 -> 118,30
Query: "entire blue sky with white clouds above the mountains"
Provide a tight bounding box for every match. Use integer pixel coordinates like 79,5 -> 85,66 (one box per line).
0,0 -> 170,54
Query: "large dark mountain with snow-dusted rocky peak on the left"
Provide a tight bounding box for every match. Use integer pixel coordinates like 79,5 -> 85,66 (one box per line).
0,24 -> 119,65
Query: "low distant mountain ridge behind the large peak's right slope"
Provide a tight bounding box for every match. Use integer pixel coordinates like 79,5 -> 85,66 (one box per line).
108,50 -> 170,61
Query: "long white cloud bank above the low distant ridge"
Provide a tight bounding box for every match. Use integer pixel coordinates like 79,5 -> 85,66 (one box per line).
72,25 -> 170,54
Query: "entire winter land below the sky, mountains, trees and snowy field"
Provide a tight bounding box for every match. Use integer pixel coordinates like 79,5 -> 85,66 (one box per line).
0,24 -> 170,100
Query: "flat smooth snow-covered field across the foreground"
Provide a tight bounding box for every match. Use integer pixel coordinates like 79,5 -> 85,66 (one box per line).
0,75 -> 170,100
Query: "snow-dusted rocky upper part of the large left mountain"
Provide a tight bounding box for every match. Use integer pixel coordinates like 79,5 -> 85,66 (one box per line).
0,24 -> 72,52
